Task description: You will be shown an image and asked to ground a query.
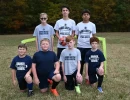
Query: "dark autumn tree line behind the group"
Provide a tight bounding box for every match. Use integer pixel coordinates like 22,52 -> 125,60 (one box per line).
0,0 -> 130,34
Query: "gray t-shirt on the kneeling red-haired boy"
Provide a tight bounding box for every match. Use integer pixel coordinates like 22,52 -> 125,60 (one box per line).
60,48 -> 81,75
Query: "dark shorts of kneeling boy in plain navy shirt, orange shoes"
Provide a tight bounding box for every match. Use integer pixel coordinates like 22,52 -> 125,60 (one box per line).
38,71 -> 55,89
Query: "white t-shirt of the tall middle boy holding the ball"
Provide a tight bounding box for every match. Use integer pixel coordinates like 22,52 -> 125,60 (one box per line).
54,19 -> 76,48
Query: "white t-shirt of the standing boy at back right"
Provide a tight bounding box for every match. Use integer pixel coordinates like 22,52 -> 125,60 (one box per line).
76,22 -> 96,48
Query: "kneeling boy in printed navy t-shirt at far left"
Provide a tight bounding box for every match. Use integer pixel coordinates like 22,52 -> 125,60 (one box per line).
10,44 -> 33,97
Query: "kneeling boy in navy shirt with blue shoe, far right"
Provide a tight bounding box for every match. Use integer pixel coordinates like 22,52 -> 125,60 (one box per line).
85,37 -> 105,93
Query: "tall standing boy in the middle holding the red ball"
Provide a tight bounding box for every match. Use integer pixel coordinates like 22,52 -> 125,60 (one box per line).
54,6 -> 75,79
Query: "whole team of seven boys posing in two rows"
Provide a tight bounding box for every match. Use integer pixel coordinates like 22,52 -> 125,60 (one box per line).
10,6 -> 105,96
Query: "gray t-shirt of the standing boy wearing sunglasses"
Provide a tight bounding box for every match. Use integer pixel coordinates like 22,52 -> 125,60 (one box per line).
33,24 -> 55,51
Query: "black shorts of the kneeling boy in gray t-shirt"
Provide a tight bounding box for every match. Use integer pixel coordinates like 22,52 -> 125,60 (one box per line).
65,70 -> 77,90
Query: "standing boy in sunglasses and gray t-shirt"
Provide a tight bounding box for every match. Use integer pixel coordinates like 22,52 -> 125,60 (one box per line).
33,13 -> 55,51
